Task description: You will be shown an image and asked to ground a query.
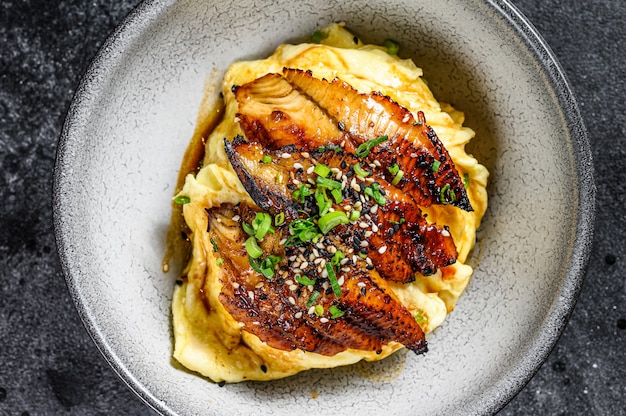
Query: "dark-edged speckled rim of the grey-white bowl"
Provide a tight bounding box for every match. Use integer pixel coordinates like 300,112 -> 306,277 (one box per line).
52,0 -> 596,416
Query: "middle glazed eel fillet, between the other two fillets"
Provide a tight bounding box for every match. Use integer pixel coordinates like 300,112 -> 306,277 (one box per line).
225,136 -> 457,283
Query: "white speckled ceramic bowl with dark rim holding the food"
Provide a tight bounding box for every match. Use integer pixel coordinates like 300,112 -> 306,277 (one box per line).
54,0 -> 594,416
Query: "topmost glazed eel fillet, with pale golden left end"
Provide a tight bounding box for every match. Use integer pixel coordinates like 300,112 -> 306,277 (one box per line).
233,68 -> 473,211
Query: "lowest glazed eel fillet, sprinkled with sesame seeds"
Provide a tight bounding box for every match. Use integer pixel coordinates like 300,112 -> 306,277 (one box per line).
207,204 -> 427,356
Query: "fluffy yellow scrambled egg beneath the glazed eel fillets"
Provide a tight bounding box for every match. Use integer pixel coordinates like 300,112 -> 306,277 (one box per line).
172,24 -> 488,382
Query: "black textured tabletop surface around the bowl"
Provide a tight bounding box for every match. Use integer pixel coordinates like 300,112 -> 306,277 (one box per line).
0,0 -> 626,416
